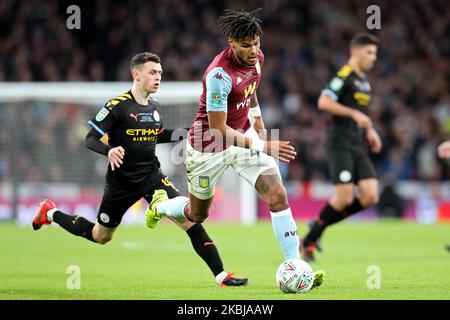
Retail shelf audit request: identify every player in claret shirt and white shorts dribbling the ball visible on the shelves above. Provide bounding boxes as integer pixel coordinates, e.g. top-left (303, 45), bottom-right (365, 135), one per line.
top-left (147, 10), bottom-right (324, 287)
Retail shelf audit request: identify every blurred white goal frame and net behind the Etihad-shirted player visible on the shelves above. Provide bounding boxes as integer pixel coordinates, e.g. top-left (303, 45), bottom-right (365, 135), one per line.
top-left (0, 82), bottom-right (256, 225)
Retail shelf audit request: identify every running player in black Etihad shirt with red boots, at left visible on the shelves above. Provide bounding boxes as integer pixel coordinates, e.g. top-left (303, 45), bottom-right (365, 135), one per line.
top-left (33, 52), bottom-right (247, 286)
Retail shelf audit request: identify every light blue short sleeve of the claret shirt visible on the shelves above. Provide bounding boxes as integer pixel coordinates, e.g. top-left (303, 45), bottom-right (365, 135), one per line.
top-left (206, 68), bottom-right (232, 112)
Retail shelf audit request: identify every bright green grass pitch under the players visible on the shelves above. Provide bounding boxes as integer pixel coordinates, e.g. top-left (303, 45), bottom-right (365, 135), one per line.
top-left (0, 221), bottom-right (450, 300)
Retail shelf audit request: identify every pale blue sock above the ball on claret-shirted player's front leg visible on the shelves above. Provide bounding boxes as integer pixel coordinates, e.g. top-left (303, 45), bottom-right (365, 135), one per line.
top-left (270, 208), bottom-right (300, 260)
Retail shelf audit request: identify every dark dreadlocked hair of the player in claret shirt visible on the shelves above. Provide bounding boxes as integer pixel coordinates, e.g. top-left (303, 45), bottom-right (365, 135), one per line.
top-left (217, 8), bottom-right (263, 41)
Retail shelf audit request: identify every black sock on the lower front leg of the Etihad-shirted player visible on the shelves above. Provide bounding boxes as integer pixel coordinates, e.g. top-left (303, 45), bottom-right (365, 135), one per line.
top-left (186, 223), bottom-right (224, 276)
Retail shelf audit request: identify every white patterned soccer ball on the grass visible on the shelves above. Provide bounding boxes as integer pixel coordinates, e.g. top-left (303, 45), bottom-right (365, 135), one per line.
top-left (275, 259), bottom-right (314, 293)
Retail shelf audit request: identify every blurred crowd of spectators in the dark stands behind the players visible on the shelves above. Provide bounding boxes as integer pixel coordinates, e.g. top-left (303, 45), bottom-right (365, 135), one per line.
top-left (0, 0), bottom-right (450, 181)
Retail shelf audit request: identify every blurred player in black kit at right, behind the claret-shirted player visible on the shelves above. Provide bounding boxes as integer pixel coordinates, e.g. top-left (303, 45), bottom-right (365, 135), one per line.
top-left (300, 33), bottom-right (382, 261)
